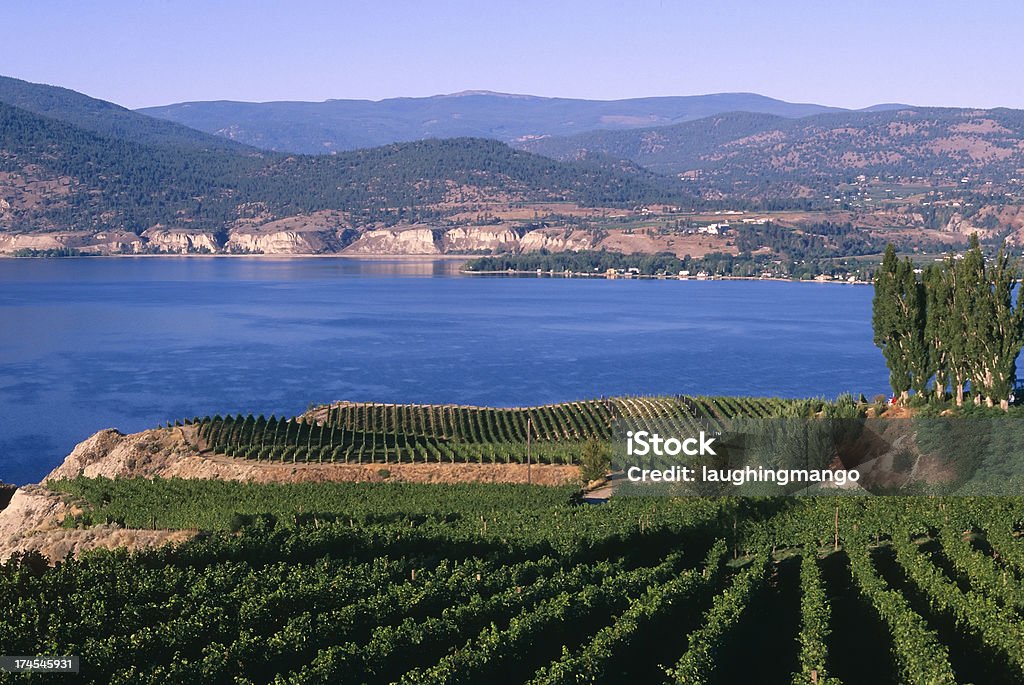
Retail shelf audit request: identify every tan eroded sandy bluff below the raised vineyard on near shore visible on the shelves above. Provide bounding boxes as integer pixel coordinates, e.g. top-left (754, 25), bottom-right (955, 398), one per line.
top-left (0, 426), bottom-right (579, 562)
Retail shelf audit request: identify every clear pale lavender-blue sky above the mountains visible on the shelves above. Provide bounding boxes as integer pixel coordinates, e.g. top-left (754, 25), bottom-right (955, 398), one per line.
top-left (0, 0), bottom-right (1024, 109)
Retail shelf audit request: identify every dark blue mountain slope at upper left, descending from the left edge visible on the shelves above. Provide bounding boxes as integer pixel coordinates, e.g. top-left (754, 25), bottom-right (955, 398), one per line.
top-left (0, 76), bottom-right (245, 151)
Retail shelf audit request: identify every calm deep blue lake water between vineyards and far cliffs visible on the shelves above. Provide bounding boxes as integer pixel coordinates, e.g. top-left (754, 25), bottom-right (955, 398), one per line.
top-left (0, 253), bottom-right (887, 483)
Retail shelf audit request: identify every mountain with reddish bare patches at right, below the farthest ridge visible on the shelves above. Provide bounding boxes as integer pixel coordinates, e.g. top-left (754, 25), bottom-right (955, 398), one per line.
top-left (517, 108), bottom-right (1024, 189)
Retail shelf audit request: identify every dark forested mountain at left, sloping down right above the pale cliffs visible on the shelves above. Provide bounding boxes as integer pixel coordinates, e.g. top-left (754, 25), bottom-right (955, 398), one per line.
top-left (0, 93), bottom-right (692, 233)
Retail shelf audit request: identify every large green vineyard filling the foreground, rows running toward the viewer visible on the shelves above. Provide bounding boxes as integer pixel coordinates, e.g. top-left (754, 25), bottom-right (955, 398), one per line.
top-left (6, 481), bottom-right (1024, 685)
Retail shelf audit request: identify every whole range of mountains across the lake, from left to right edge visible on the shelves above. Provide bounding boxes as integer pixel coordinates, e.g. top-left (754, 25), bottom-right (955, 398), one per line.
top-left (6, 72), bottom-right (1024, 252)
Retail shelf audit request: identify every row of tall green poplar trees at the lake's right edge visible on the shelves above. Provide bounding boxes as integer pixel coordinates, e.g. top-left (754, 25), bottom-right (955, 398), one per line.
top-left (871, 236), bottom-right (1024, 410)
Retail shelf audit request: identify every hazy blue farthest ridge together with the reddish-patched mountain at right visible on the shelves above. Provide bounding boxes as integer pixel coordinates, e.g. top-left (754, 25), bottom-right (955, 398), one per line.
top-left (134, 91), bottom-right (1024, 201)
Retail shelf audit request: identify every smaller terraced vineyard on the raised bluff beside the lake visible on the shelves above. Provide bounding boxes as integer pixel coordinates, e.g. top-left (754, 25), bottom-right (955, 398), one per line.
top-left (186, 396), bottom-right (806, 464)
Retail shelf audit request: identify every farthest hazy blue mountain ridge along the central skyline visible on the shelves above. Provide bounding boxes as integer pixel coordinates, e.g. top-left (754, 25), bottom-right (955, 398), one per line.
top-left (139, 91), bottom-right (840, 154)
